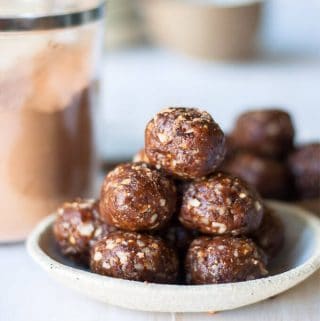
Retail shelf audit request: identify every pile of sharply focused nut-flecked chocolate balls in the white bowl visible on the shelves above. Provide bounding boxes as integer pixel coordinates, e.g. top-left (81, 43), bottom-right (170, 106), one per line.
top-left (53, 108), bottom-right (284, 284)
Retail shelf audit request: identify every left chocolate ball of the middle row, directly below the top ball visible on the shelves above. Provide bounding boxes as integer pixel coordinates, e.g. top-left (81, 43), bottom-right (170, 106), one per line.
top-left (100, 163), bottom-right (177, 231)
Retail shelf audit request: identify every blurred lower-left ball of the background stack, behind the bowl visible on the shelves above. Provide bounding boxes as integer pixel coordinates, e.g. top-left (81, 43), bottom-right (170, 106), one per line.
top-left (222, 152), bottom-right (290, 199)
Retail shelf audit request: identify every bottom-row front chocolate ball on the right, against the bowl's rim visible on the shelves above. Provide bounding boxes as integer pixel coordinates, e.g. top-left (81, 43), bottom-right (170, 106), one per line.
top-left (185, 236), bottom-right (268, 284)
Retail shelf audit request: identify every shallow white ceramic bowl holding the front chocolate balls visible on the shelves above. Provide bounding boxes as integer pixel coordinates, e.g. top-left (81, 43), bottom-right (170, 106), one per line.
top-left (27, 202), bottom-right (320, 312)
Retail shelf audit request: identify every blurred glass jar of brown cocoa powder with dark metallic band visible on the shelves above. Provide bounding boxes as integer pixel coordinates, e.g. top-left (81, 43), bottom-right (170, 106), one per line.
top-left (0, 0), bottom-right (104, 242)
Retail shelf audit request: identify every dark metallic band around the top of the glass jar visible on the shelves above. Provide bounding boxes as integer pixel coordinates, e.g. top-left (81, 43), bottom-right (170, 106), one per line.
top-left (0, 1), bottom-right (105, 33)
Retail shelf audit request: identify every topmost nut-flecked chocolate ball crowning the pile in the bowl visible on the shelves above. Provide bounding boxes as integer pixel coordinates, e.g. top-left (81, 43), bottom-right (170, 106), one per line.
top-left (145, 108), bottom-right (225, 179)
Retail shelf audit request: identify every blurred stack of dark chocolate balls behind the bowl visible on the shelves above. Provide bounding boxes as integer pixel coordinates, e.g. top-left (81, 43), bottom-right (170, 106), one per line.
top-left (222, 109), bottom-right (320, 201)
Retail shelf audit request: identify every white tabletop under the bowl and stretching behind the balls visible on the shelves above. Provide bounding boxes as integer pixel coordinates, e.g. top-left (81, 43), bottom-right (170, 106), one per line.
top-left (0, 49), bottom-right (320, 321)
